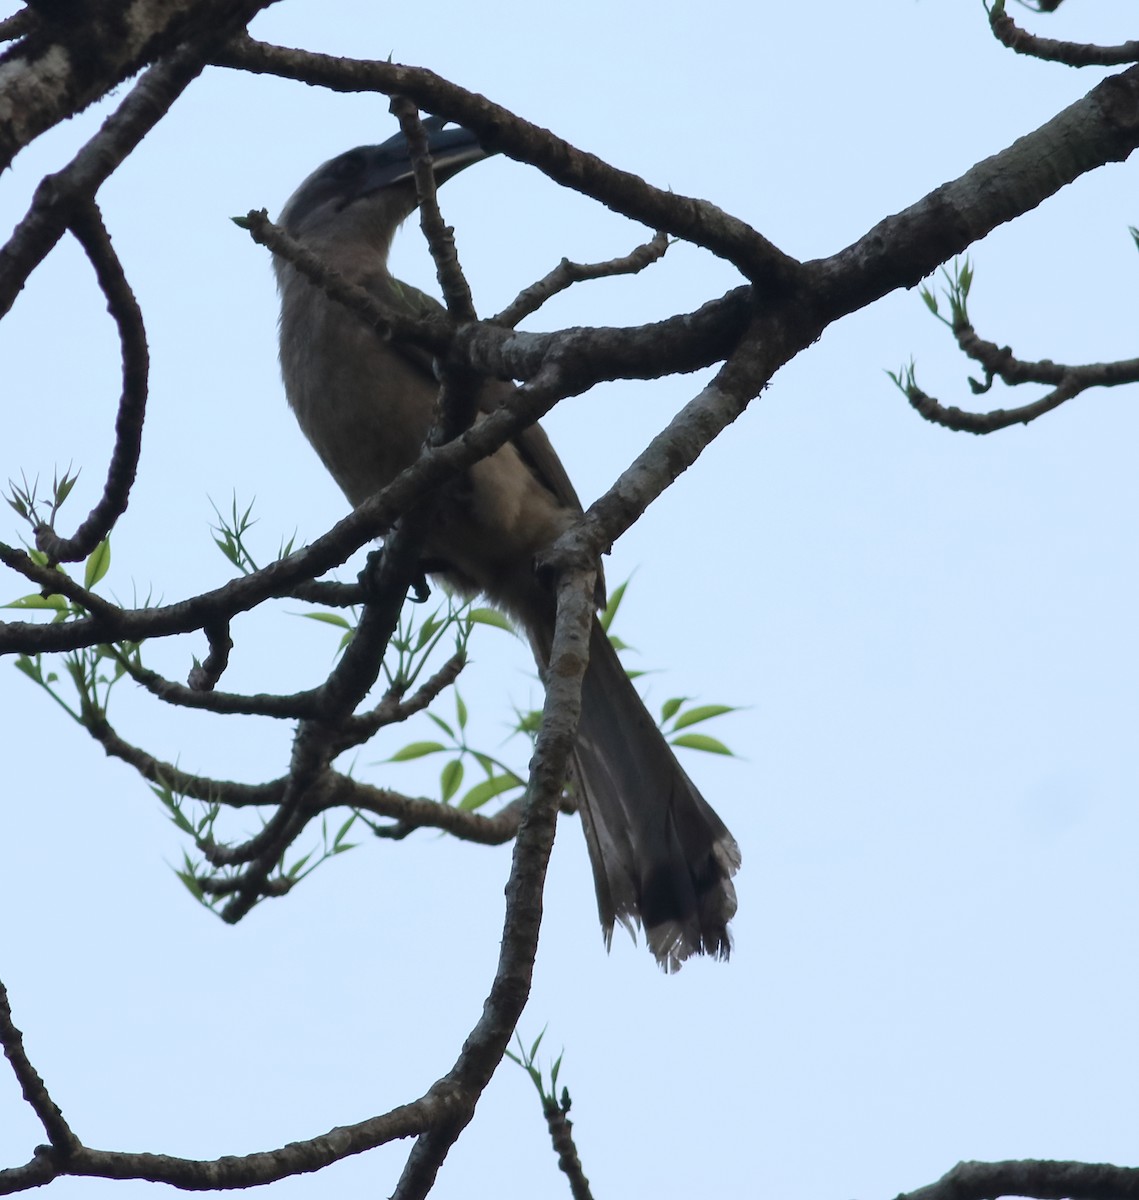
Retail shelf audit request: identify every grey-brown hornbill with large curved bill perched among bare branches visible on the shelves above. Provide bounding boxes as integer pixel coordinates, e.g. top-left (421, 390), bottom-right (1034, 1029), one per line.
top-left (274, 116), bottom-right (741, 972)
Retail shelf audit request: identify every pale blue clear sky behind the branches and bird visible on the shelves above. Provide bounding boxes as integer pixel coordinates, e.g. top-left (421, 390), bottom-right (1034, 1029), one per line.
top-left (0, 0), bottom-right (1139, 1200)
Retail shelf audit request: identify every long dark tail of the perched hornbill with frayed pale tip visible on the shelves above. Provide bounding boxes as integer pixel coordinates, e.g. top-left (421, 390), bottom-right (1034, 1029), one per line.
top-left (574, 618), bottom-right (739, 971)
